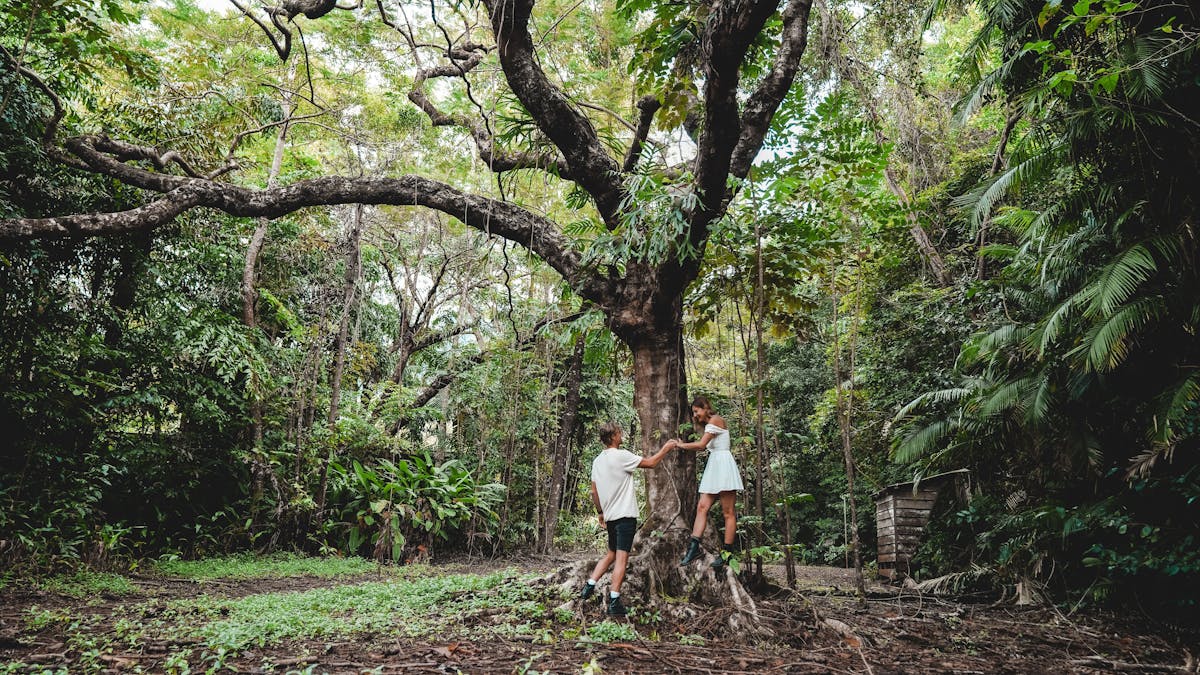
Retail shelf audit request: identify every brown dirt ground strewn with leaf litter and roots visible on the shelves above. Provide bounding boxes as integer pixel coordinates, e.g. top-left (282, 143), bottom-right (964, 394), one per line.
top-left (0, 556), bottom-right (1200, 675)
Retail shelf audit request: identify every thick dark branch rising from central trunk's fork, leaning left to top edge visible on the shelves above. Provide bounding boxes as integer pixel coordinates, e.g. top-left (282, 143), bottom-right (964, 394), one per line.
top-left (485, 0), bottom-right (622, 228)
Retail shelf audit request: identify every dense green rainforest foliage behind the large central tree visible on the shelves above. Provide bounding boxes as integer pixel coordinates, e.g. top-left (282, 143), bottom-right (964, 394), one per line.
top-left (0, 0), bottom-right (1200, 613)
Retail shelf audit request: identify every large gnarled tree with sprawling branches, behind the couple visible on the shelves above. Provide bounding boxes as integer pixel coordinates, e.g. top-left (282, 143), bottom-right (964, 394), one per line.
top-left (0, 0), bottom-right (811, 614)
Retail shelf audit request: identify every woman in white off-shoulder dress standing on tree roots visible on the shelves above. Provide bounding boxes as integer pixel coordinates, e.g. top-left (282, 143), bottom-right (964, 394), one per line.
top-left (676, 396), bottom-right (744, 569)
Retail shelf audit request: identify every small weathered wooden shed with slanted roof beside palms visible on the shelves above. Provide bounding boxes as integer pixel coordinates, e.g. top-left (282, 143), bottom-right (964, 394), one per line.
top-left (875, 468), bottom-right (970, 581)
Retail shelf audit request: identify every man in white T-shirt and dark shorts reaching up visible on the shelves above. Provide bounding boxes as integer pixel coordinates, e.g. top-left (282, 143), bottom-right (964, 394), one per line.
top-left (580, 422), bottom-right (678, 616)
